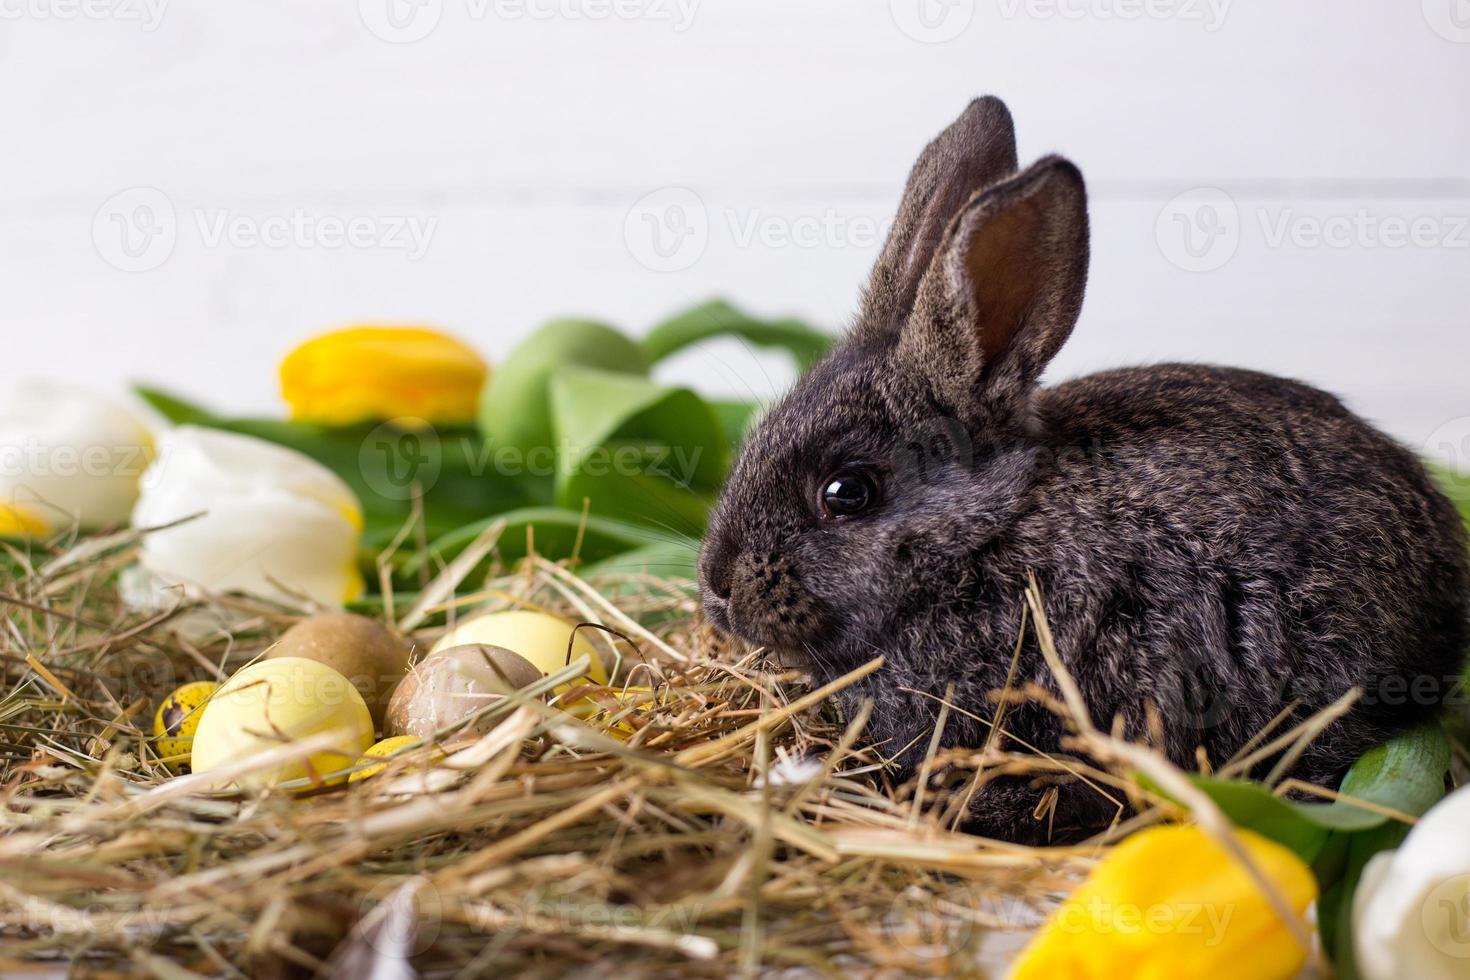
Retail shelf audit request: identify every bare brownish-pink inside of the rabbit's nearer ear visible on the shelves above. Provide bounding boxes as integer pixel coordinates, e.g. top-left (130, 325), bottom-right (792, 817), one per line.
top-left (964, 200), bottom-right (1047, 361)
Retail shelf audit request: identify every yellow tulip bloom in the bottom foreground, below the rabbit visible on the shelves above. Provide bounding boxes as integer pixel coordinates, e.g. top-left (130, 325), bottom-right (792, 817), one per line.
top-left (1010, 826), bottom-right (1317, 980)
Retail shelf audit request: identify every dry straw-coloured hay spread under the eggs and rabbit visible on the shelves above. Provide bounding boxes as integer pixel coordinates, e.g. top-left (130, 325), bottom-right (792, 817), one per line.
top-left (0, 535), bottom-right (1193, 977)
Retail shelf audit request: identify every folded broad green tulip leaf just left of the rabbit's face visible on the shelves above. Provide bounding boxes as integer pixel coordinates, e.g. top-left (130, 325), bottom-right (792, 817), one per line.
top-left (551, 367), bottom-right (729, 536)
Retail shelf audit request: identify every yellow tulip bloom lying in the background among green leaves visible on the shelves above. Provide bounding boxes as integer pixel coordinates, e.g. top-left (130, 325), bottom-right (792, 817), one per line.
top-left (281, 326), bottom-right (488, 425)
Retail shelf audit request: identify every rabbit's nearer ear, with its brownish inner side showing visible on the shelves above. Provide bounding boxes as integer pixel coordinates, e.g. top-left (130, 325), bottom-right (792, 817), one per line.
top-left (900, 157), bottom-right (1088, 416)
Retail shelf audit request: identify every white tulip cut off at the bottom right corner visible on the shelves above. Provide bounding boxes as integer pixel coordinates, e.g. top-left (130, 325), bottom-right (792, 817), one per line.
top-left (1352, 786), bottom-right (1470, 980)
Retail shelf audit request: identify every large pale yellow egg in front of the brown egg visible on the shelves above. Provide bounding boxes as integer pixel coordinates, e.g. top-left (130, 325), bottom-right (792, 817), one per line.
top-left (193, 657), bottom-right (372, 788)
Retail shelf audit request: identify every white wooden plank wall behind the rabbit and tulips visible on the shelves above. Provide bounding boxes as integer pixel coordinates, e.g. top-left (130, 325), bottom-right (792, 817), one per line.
top-left (0, 0), bottom-right (1470, 464)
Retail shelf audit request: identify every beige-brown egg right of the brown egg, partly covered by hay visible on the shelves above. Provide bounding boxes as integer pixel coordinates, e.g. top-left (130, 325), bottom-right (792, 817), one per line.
top-left (384, 644), bottom-right (542, 739)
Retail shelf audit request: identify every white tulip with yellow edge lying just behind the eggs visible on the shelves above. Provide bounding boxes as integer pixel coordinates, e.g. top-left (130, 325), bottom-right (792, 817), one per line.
top-left (132, 426), bottom-right (363, 607)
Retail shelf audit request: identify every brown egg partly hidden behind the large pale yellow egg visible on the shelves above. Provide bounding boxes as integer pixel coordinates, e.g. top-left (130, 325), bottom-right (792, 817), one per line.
top-left (266, 613), bottom-right (409, 724)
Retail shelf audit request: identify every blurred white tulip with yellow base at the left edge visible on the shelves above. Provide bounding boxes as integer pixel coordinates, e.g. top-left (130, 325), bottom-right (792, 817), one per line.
top-left (0, 381), bottom-right (153, 533)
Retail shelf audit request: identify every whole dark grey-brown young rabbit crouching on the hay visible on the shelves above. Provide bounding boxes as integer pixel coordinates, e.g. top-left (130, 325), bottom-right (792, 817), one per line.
top-left (700, 98), bottom-right (1470, 840)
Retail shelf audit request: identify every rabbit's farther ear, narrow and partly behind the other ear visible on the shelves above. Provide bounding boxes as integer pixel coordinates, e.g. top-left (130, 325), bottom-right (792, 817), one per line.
top-left (858, 96), bottom-right (1016, 332)
